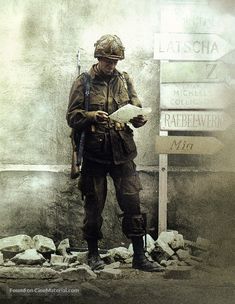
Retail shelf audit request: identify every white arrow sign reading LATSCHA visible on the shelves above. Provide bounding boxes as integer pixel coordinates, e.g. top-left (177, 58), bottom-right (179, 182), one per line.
top-left (154, 33), bottom-right (232, 61)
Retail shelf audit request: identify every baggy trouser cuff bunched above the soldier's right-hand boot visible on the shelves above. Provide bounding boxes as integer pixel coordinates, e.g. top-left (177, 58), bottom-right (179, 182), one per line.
top-left (122, 214), bottom-right (146, 238)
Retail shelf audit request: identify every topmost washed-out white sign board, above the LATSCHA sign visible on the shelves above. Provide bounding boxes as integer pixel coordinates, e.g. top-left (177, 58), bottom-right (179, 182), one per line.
top-left (161, 1), bottom-right (219, 33)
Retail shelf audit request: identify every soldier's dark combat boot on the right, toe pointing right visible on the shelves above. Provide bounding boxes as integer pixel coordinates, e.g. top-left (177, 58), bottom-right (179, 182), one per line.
top-left (132, 236), bottom-right (165, 272)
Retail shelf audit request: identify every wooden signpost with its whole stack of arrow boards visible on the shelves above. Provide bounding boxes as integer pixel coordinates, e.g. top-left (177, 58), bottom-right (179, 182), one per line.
top-left (154, 0), bottom-right (233, 234)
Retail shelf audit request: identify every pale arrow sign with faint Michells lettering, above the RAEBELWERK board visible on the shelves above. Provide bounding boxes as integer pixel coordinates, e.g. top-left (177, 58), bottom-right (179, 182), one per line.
top-left (160, 83), bottom-right (233, 109)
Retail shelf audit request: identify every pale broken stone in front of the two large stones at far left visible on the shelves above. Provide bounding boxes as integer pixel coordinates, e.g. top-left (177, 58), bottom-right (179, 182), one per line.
top-left (11, 249), bottom-right (45, 265)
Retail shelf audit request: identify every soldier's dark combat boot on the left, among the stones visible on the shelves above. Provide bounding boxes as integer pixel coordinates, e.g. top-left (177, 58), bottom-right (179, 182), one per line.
top-left (87, 239), bottom-right (105, 270)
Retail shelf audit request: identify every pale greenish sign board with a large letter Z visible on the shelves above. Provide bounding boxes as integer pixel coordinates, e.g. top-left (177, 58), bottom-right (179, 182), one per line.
top-left (161, 61), bottom-right (229, 83)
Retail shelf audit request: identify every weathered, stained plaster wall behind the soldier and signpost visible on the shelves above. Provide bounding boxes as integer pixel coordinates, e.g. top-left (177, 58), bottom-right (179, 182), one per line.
top-left (0, 0), bottom-right (235, 258)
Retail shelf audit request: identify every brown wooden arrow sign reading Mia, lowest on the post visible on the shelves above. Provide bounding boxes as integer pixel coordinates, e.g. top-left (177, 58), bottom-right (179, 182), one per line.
top-left (155, 136), bottom-right (223, 155)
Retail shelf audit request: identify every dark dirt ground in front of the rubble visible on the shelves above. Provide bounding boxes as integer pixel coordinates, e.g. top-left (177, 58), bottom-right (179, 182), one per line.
top-left (0, 266), bottom-right (235, 304)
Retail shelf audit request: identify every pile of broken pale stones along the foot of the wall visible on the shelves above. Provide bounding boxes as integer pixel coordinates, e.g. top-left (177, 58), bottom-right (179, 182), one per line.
top-left (0, 231), bottom-right (211, 282)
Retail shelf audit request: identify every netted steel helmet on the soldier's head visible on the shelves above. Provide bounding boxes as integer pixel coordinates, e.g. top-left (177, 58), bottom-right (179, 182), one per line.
top-left (94, 35), bottom-right (125, 60)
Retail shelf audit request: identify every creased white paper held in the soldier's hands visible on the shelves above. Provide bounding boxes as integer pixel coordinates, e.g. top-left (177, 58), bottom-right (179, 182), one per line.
top-left (109, 104), bottom-right (152, 123)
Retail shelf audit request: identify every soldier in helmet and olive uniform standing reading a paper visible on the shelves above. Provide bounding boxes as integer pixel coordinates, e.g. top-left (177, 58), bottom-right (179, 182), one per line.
top-left (67, 35), bottom-right (163, 272)
